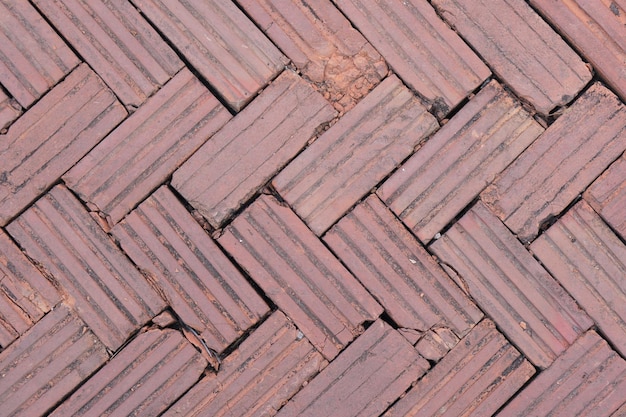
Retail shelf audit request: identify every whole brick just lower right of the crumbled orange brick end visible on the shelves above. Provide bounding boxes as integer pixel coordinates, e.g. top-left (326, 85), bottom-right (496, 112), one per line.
top-left (272, 76), bottom-right (437, 235)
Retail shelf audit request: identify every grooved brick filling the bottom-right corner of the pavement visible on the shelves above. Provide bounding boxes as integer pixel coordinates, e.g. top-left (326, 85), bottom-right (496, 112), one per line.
top-left (498, 331), bottom-right (626, 417)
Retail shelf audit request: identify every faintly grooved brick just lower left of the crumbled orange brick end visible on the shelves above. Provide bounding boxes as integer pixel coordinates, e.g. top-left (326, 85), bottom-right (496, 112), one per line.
top-left (172, 71), bottom-right (335, 227)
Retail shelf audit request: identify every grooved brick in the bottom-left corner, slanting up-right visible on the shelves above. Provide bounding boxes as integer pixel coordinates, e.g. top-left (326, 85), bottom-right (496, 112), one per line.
top-left (0, 304), bottom-right (108, 417)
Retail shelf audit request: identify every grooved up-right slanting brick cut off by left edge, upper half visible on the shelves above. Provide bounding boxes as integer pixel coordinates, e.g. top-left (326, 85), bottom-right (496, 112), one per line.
top-left (0, 65), bottom-right (126, 226)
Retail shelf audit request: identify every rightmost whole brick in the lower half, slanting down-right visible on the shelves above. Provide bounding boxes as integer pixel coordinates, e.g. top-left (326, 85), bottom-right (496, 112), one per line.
top-left (431, 202), bottom-right (593, 368)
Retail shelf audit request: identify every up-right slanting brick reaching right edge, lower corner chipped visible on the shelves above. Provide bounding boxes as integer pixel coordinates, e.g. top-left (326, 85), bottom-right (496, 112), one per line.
top-left (481, 84), bottom-right (626, 242)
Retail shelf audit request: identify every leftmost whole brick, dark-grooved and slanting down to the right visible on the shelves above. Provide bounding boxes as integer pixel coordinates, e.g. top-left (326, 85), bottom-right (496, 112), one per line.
top-left (7, 185), bottom-right (165, 350)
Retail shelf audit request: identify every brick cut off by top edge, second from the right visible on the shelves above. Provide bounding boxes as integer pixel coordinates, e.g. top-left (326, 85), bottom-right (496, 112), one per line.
top-left (433, 0), bottom-right (591, 114)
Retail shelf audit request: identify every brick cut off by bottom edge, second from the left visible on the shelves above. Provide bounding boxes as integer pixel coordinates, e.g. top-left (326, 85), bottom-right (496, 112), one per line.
top-left (50, 329), bottom-right (207, 416)
